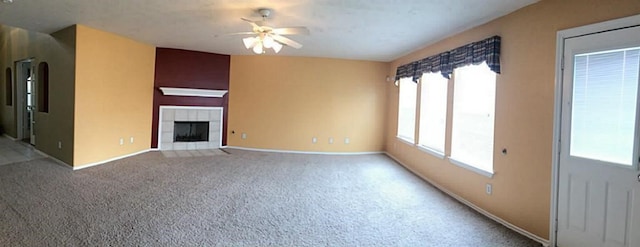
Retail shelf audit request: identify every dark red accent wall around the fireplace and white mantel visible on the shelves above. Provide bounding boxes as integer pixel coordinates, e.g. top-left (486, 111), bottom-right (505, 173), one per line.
top-left (151, 48), bottom-right (231, 148)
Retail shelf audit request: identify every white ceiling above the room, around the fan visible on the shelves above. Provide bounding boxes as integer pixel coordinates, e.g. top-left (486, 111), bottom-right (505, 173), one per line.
top-left (0, 0), bottom-right (538, 61)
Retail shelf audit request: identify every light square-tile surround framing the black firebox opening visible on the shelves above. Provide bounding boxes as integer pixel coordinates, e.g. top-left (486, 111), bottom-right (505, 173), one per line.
top-left (158, 106), bottom-right (223, 150)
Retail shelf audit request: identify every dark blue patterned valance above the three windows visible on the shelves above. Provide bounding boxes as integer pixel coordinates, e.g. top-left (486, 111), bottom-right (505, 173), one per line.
top-left (396, 36), bottom-right (500, 82)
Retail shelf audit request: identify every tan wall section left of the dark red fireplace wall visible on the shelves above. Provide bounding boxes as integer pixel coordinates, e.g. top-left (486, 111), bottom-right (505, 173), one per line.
top-left (73, 25), bottom-right (155, 167)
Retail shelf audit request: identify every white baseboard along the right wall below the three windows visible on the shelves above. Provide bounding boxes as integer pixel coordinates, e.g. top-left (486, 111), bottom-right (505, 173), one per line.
top-left (385, 153), bottom-right (549, 247)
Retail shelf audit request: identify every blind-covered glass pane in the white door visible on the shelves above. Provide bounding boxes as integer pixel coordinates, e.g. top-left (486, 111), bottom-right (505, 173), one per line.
top-left (570, 48), bottom-right (640, 165)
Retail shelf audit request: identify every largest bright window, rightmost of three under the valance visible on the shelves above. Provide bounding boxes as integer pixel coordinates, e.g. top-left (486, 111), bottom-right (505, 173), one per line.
top-left (451, 63), bottom-right (496, 175)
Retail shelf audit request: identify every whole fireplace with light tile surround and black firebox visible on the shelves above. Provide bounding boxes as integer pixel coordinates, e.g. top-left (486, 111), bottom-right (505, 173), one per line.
top-left (158, 106), bottom-right (222, 150)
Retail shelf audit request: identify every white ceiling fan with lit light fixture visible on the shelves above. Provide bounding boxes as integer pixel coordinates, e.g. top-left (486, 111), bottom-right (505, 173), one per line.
top-left (232, 8), bottom-right (310, 54)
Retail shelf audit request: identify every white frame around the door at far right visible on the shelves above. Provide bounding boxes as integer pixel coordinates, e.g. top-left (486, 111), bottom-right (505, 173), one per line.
top-left (549, 15), bottom-right (640, 246)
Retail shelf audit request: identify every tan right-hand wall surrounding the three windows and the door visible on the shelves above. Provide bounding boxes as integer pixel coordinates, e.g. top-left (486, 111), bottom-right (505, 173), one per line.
top-left (386, 0), bottom-right (640, 238)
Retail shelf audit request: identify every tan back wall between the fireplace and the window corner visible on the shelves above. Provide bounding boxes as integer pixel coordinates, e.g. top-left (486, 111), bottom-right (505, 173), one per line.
top-left (228, 56), bottom-right (389, 152)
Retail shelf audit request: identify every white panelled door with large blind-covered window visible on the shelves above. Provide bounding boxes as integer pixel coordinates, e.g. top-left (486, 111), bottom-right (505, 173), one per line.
top-left (557, 26), bottom-right (640, 247)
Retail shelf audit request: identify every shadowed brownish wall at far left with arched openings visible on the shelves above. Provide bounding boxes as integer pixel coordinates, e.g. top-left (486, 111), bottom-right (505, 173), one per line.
top-left (0, 25), bottom-right (75, 163)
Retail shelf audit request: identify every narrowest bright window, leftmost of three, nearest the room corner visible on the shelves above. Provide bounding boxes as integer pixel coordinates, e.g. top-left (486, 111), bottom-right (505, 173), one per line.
top-left (398, 78), bottom-right (418, 142)
